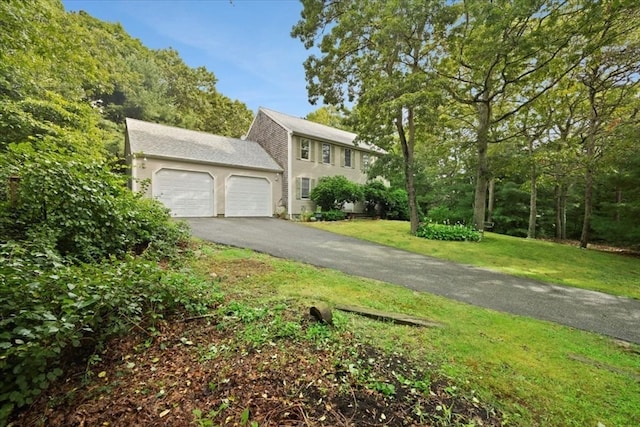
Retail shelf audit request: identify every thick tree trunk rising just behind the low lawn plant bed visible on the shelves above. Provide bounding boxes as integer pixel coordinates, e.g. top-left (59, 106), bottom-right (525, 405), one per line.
top-left (473, 101), bottom-right (491, 231)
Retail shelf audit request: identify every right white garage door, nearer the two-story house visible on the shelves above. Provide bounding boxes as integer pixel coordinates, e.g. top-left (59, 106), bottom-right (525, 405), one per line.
top-left (224, 175), bottom-right (272, 216)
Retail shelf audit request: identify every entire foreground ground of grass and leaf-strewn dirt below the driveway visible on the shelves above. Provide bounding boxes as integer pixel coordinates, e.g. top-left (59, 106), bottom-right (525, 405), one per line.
top-left (10, 244), bottom-right (640, 426)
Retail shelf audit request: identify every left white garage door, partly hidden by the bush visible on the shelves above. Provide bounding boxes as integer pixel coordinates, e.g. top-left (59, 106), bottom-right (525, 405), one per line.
top-left (152, 169), bottom-right (213, 217)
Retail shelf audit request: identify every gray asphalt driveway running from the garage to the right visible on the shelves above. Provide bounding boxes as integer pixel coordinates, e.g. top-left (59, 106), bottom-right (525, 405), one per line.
top-left (187, 218), bottom-right (640, 344)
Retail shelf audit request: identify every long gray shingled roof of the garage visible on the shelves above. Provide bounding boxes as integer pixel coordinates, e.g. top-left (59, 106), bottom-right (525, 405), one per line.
top-left (126, 118), bottom-right (282, 171)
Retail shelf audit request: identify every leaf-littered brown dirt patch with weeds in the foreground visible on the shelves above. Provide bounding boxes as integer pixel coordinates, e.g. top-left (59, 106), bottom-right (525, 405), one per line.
top-left (13, 306), bottom-right (500, 426)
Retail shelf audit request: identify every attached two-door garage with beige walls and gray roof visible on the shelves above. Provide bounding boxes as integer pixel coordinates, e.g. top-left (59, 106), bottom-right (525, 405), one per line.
top-left (125, 119), bottom-right (283, 217)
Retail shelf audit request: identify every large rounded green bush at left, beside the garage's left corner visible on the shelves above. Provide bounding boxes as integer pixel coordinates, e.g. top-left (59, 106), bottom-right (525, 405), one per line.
top-left (0, 147), bottom-right (186, 262)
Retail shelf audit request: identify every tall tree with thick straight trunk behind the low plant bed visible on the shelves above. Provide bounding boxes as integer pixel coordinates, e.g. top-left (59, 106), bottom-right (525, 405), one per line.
top-left (437, 0), bottom-right (604, 229)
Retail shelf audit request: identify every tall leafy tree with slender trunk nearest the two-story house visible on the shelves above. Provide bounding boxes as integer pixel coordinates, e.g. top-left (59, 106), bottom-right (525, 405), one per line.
top-left (292, 0), bottom-right (446, 233)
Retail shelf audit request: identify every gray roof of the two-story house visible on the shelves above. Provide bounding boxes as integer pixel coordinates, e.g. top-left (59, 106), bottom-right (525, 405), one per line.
top-left (260, 107), bottom-right (381, 152)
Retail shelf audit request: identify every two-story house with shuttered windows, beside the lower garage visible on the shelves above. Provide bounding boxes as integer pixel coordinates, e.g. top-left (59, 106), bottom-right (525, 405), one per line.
top-left (246, 107), bottom-right (380, 218)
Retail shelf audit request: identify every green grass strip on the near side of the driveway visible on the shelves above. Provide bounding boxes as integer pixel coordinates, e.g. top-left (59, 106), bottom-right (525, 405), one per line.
top-left (190, 246), bottom-right (640, 426)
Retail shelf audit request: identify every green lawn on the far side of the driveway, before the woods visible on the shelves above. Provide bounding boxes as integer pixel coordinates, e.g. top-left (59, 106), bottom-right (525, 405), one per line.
top-left (305, 220), bottom-right (640, 299)
